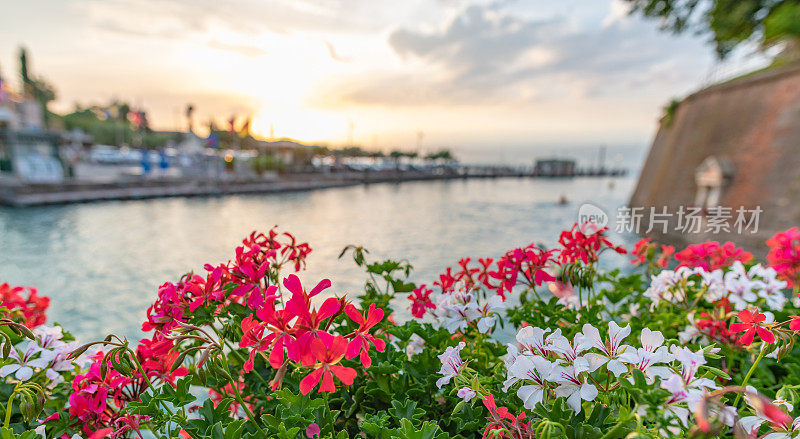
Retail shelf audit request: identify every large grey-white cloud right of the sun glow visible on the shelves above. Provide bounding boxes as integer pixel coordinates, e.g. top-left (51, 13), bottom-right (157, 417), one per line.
top-left (316, 3), bottom-right (707, 105)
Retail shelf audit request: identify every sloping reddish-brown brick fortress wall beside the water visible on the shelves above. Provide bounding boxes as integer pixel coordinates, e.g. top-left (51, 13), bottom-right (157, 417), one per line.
top-left (630, 65), bottom-right (800, 254)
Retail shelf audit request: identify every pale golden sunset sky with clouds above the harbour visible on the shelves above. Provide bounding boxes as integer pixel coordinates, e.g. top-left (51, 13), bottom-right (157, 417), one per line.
top-left (0, 0), bottom-right (764, 148)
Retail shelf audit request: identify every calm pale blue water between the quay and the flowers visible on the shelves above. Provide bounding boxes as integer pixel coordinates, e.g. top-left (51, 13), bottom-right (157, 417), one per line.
top-left (0, 177), bottom-right (635, 341)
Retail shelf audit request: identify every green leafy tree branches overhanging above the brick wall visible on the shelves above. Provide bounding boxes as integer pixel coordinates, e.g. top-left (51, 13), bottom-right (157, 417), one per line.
top-left (625, 0), bottom-right (800, 58)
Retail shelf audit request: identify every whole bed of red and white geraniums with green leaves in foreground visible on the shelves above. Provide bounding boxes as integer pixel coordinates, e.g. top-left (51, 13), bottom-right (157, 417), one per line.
top-left (7, 224), bottom-right (800, 439)
